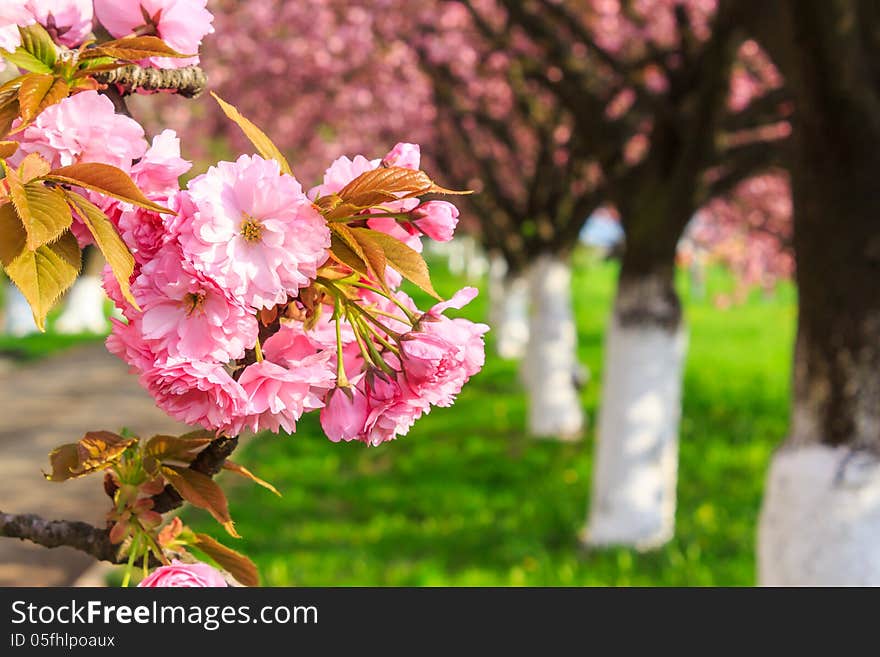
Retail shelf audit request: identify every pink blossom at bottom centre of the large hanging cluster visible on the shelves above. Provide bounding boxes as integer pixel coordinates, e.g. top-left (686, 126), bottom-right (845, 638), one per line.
top-left (230, 352), bottom-right (336, 434)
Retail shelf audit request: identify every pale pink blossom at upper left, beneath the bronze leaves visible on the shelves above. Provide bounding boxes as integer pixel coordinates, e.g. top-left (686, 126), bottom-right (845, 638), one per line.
top-left (16, 91), bottom-right (147, 171)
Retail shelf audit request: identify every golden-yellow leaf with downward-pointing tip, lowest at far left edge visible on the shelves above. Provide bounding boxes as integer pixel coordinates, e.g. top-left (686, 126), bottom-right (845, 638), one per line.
top-left (0, 211), bottom-right (81, 331)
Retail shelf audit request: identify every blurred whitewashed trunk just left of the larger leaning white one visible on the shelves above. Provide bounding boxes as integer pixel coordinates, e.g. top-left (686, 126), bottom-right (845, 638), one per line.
top-left (524, 255), bottom-right (584, 440)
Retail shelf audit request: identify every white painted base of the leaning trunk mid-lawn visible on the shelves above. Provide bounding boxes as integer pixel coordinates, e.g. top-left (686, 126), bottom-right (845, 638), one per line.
top-left (584, 317), bottom-right (687, 549)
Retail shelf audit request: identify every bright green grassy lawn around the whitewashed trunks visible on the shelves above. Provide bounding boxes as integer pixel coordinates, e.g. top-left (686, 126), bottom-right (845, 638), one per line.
top-left (185, 254), bottom-right (795, 586)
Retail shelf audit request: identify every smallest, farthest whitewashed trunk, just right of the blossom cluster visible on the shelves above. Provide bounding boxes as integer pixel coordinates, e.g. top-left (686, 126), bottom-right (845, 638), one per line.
top-left (489, 254), bottom-right (529, 360)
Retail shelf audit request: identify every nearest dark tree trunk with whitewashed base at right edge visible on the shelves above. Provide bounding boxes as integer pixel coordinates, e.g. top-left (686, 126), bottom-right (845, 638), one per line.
top-left (758, 0), bottom-right (880, 586)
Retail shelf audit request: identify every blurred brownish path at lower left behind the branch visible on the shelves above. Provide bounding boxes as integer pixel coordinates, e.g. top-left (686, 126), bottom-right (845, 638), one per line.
top-left (0, 343), bottom-right (185, 586)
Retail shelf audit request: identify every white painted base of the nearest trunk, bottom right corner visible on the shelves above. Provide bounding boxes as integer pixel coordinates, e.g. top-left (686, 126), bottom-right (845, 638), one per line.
top-left (758, 445), bottom-right (880, 586)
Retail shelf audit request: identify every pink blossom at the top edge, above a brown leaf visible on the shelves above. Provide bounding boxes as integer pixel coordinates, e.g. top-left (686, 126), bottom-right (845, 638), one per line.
top-left (95, 0), bottom-right (214, 68)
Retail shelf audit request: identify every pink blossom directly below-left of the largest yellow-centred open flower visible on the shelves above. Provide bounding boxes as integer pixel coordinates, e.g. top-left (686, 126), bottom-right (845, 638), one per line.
top-left (132, 246), bottom-right (257, 363)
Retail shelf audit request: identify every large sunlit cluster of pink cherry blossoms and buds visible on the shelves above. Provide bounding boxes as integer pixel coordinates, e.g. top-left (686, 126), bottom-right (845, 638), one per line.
top-left (105, 140), bottom-right (488, 445)
